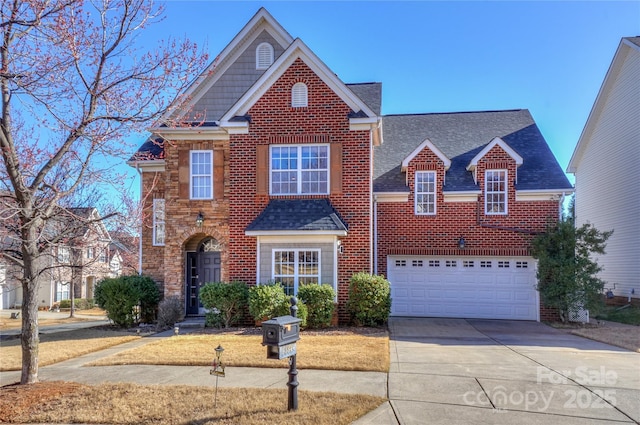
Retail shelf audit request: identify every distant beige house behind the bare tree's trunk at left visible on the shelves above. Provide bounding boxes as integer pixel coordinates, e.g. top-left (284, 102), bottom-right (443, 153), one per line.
top-left (0, 208), bottom-right (113, 309)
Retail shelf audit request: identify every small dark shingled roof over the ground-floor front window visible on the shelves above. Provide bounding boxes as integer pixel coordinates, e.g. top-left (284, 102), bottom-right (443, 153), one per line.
top-left (245, 199), bottom-right (347, 236)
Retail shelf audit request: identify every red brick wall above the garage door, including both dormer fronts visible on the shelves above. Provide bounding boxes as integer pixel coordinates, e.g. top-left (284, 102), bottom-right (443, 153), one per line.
top-left (377, 142), bottom-right (559, 319)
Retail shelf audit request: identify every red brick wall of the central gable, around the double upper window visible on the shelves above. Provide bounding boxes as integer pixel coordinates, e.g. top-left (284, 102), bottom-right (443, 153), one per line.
top-left (229, 59), bottom-right (371, 318)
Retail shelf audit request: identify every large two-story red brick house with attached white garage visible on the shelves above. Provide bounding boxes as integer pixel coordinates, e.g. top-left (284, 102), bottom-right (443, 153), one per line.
top-left (129, 9), bottom-right (573, 320)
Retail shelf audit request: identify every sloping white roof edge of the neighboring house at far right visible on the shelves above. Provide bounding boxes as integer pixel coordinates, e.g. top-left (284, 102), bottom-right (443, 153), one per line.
top-left (567, 37), bottom-right (640, 173)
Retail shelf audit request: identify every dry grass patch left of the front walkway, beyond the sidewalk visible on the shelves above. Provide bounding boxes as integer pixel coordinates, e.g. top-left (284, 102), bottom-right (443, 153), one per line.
top-left (0, 329), bottom-right (140, 371)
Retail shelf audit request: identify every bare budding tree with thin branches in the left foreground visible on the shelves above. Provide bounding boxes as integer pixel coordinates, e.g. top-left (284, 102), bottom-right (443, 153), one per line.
top-left (0, 0), bottom-right (207, 384)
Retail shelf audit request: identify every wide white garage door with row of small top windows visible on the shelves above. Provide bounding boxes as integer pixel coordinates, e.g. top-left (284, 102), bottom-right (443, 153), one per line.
top-left (387, 256), bottom-right (539, 320)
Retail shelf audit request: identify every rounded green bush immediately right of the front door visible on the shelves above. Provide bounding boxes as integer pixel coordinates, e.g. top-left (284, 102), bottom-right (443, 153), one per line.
top-left (199, 282), bottom-right (249, 328)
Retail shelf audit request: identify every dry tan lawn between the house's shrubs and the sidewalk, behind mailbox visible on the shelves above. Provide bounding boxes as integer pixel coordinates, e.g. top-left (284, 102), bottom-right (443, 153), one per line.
top-left (90, 332), bottom-right (389, 372)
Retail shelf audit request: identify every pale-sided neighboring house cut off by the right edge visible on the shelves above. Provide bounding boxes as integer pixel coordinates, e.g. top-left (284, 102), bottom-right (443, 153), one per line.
top-left (567, 37), bottom-right (640, 301)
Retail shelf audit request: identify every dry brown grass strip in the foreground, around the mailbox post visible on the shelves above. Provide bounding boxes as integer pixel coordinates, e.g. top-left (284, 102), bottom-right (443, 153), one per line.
top-left (0, 382), bottom-right (386, 425)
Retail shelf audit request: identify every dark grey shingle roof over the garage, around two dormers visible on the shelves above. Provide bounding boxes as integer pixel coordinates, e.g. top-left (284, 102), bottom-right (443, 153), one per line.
top-left (373, 109), bottom-right (573, 192)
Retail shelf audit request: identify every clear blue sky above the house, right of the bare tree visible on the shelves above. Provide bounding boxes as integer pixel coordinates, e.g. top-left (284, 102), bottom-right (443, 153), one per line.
top-left (124, 0), bottom-right (640, 192)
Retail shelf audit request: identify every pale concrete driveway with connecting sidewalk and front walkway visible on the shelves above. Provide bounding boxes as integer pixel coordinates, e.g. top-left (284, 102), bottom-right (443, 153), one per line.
top-left (0, 318), bottom-right (640, 425)
